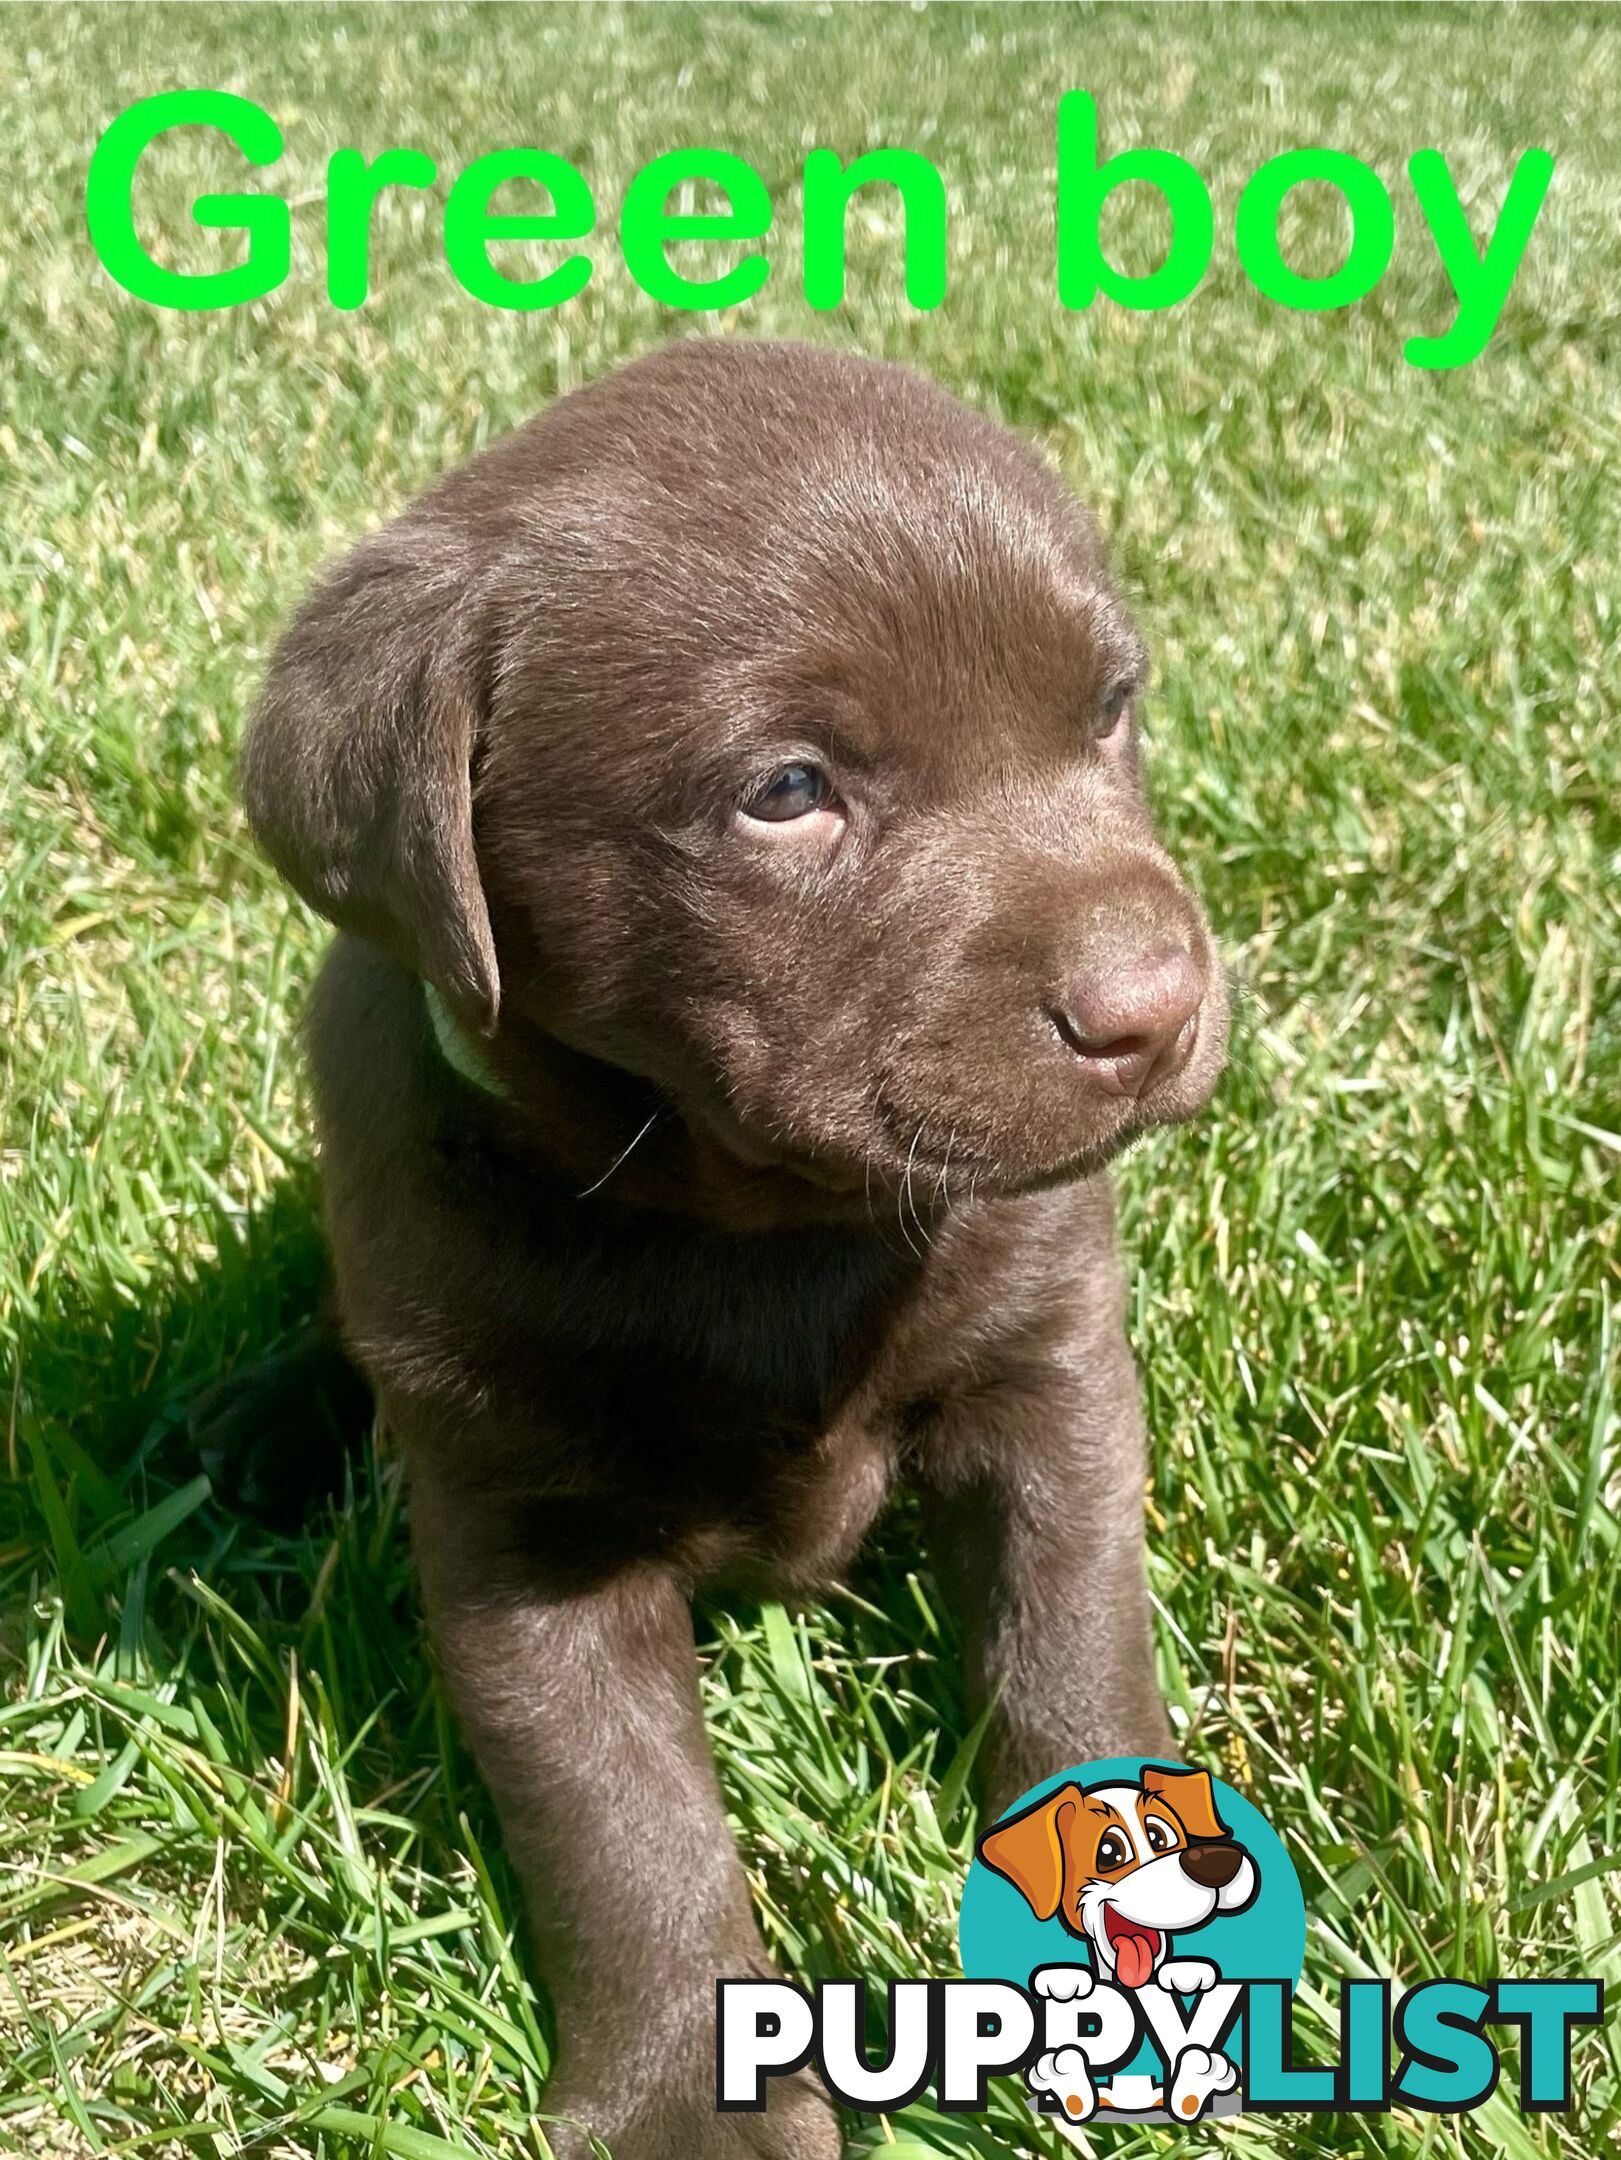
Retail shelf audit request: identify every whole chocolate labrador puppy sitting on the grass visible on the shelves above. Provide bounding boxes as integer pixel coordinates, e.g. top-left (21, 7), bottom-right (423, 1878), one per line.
top-left (234, 339), bottom-right (1225, 2160)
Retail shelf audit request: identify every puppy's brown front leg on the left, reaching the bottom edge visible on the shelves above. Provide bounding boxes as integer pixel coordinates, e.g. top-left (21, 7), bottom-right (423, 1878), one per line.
top-left (413, 1464), bottom-right (839, 2160)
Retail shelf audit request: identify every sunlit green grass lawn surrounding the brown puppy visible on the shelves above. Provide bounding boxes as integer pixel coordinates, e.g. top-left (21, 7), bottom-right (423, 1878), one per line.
top-left (0, 6), bottom-right (1621, 2160)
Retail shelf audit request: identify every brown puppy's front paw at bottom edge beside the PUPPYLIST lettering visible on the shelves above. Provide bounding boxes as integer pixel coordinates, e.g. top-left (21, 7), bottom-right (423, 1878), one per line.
top-left (542, 2071), bottom-right (843, 2160)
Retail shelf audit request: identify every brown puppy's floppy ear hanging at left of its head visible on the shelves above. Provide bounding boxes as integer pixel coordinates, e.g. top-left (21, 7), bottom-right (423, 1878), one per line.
top-left (242, 514), bottom-right (499, 1028)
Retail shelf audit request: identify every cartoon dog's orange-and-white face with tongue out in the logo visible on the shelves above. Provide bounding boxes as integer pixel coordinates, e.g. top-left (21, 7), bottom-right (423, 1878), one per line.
top-left (979, 1763), bottom-right (1260, 1987)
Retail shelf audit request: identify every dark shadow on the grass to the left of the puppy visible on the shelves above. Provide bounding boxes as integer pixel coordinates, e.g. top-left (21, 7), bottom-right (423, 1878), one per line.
top-left (0, 1166), bottom-right (493, 1874)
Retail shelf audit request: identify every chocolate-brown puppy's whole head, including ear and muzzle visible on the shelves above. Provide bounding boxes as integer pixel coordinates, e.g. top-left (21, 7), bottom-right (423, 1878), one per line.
top-left (244, 341), bottom-right (1225, 1192)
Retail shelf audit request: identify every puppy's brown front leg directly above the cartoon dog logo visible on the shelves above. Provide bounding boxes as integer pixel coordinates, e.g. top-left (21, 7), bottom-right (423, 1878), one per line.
top-left (919, 1298), bottom-right (1171, 1814)
